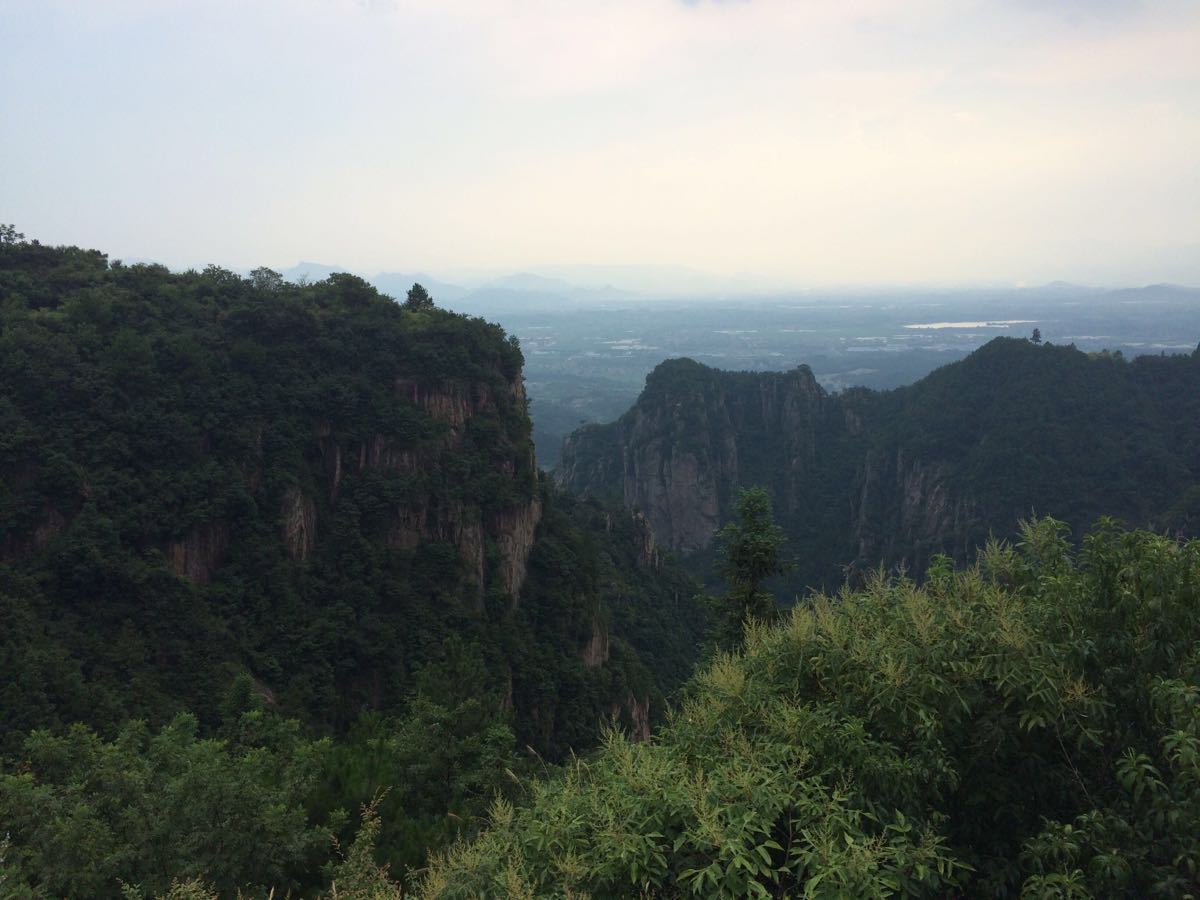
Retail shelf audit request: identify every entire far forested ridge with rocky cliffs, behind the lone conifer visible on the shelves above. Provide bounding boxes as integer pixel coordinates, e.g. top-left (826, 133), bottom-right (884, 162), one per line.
top-left (558, 338), bottom-right (1200, 589)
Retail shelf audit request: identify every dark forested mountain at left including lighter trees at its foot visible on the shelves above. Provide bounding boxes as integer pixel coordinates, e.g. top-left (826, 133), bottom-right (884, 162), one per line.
top-left (0, 234), bottom-right (703, 895)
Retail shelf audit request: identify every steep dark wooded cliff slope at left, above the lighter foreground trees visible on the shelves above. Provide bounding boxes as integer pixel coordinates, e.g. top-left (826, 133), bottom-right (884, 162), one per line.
top-left (0, 242), bottom-right (691, 755)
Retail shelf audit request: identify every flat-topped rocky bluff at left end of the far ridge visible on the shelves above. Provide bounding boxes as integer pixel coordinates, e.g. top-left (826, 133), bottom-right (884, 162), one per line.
top-left (558, 360), bottom-right (874, 588)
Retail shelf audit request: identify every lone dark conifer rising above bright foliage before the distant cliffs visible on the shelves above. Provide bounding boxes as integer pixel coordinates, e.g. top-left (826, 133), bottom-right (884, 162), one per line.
top-left (716, 487), bottom-right (791, 647)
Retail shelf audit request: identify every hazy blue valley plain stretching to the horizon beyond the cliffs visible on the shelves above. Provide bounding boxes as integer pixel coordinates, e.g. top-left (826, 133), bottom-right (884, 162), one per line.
top-left (270, 264), bottom-right (1200, 469)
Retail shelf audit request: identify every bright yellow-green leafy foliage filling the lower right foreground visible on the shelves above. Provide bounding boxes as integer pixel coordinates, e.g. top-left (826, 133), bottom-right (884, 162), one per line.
top-left (422, 520), bottom-right (1200, 898)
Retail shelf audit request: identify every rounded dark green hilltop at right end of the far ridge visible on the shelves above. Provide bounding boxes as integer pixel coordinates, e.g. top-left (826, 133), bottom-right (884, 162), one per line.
top-left (869, 338), bottom-right (1200, 564)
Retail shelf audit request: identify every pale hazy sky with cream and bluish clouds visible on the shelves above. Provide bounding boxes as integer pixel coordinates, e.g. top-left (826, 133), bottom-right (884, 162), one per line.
top-left (0, 0), bottom-right (1200, 286)
